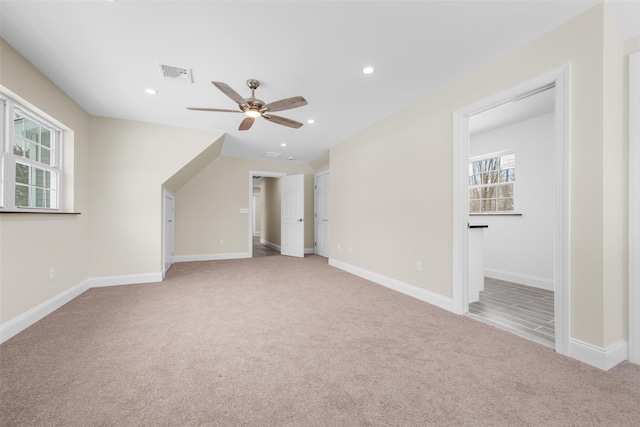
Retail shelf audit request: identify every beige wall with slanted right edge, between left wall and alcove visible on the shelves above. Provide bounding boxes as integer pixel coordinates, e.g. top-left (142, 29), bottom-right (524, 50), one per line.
top-left (90, 117), bottom-right (221, 277)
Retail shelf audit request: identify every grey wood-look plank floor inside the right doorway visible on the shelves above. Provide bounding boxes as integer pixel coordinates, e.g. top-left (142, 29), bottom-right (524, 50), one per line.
top-left (469, 277), bottom-right (555, 348)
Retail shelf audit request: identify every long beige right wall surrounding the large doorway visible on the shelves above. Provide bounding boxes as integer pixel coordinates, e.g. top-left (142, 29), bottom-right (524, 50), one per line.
top-left (330, 5), bottom-right (626, 347)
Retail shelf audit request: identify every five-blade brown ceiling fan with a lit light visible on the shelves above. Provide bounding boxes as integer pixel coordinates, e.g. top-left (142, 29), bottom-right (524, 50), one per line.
top-left (187, 79), bottom-right (307, 130)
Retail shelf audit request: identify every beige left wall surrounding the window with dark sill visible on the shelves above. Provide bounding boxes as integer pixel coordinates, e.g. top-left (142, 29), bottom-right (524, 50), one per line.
top-left (0, 39), bottom-right (92, 324)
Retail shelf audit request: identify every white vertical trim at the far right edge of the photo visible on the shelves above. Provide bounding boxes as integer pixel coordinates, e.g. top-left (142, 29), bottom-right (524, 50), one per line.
top-left (629, 52), bottom-right (640, 363)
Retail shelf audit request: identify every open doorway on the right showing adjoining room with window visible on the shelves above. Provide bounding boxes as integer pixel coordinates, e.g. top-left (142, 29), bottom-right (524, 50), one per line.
top-left (468, 85), bottom-right (555, 348)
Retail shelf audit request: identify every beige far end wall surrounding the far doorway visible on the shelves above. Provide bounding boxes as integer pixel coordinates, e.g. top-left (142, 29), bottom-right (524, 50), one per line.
top-left (175, 157), bottom-right (313, 256)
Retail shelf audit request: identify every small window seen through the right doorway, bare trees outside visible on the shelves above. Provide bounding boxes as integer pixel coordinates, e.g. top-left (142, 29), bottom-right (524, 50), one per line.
top-left (469, 153), bottom-right (516, 213)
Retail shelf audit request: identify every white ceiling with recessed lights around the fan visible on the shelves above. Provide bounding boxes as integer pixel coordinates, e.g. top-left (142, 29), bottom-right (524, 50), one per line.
top-left (0, 0), bottom-right (640, 162)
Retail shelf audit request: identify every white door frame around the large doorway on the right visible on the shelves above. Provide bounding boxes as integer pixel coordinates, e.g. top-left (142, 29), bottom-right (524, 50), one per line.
top-left (452, 64), bottom-right (571, 355)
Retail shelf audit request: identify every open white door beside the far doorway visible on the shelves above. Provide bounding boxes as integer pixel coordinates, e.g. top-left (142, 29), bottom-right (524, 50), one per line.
top-left (280, 175), bottom-right (304, 258)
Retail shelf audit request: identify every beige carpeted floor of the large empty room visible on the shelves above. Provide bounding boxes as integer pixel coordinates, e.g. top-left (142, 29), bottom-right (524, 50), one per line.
top-left (0, 256), bottom-right (640, 426)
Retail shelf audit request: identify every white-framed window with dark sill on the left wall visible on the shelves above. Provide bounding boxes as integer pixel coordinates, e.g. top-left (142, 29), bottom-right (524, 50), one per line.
top-left (0, 97), bottom-right (62, 210)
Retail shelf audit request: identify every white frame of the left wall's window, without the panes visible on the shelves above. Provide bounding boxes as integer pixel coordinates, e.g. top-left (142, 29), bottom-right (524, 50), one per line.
top-left (0, 94), bottom-right (64, 212)
